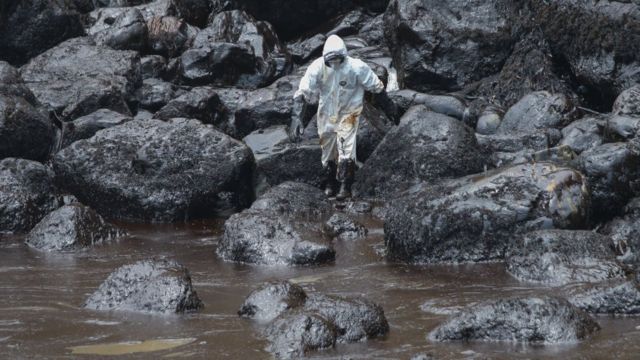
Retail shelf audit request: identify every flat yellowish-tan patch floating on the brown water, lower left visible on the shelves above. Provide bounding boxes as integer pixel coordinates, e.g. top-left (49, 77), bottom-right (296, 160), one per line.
top-left (68, 338), bottom-right (196, 356)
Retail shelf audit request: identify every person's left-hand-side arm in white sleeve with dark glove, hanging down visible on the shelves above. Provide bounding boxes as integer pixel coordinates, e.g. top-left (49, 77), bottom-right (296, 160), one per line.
top-left (289, 61), bottom-right (321, 141)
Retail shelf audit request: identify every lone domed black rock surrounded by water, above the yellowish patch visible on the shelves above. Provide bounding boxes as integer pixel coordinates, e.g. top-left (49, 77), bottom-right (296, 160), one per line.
top-left (84, 260), bottom-right (202, 314)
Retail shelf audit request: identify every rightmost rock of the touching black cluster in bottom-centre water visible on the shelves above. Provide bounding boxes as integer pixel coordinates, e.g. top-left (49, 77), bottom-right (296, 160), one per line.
top-left (304, 293), bottom-right (389, 343)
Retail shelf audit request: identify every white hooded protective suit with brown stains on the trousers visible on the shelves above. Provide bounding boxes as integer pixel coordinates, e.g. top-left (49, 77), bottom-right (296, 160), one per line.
top-left (294, 35), bottom-right (384, 166)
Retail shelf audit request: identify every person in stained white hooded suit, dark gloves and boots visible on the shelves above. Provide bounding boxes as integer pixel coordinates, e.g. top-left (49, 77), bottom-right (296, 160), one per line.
top-left (290, 35), bottom-right (393, 200)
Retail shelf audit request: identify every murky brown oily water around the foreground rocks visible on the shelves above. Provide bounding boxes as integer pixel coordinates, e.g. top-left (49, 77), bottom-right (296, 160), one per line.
top-left (0, 214), bottom-right (640, 360)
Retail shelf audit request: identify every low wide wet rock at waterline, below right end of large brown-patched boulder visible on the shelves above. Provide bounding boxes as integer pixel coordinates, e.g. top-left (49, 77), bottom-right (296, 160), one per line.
top-left (506, 230), bottom-right (625, 285)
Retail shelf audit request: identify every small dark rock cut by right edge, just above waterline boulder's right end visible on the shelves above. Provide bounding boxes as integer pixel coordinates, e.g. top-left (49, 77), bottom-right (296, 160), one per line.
top-left (599, 198), bottom-right (640, 268)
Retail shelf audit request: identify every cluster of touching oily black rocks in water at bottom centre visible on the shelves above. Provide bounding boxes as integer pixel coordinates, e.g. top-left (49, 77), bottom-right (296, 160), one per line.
top-left (238, 282), bottom-right (389, 359)
